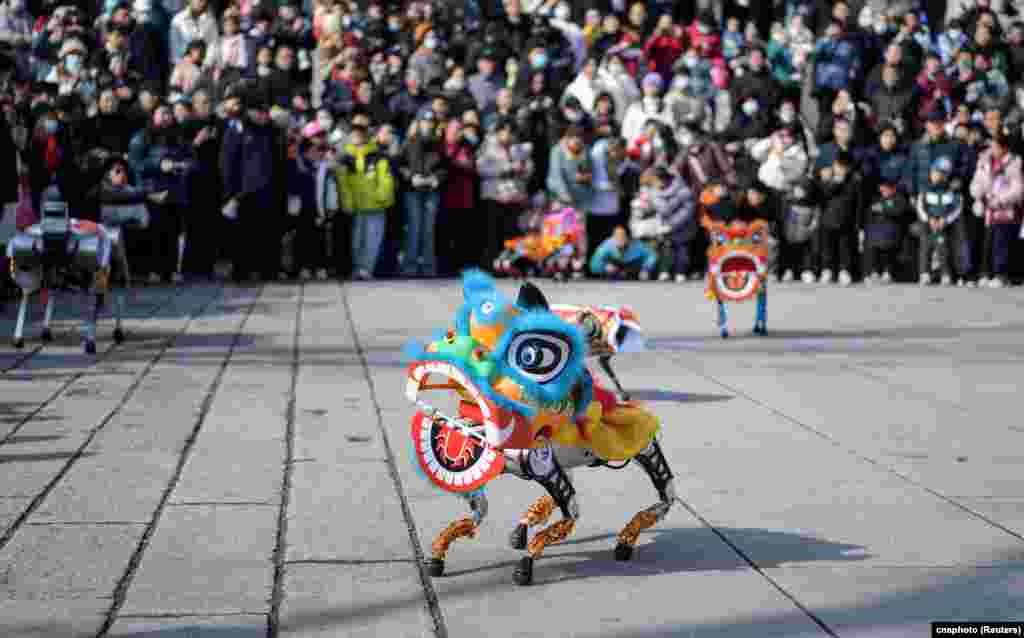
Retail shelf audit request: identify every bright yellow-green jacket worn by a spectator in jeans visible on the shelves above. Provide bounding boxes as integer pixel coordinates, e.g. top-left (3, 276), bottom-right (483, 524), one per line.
top-left (335, 142), bottom-right (395, 215)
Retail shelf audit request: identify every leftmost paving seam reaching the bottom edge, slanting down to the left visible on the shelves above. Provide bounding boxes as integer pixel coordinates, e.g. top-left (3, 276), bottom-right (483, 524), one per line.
top-left (96, 285), bottom-right (266, 638)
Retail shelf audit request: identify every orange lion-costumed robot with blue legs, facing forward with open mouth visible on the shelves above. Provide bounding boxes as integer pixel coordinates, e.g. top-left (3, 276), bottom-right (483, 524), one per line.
top-left (700, 185), bottom-right (769, 339)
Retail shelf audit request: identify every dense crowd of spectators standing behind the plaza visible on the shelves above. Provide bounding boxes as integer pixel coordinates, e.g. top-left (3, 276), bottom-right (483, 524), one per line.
top-left (0, 0), bottom-right (1024, 287)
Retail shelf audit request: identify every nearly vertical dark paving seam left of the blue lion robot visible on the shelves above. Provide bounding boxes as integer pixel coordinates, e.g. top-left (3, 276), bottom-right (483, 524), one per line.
top-left (266, 284), bottom-right (306, 638)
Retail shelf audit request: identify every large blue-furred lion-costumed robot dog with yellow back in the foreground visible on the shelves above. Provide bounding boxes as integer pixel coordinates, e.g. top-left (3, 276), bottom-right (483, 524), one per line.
top-left (406, 271), bottom-right (676, 585)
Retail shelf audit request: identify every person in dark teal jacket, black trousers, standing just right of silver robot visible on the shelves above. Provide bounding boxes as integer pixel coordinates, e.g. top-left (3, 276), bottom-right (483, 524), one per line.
top-left (128, 103), bottom-right (199, 284)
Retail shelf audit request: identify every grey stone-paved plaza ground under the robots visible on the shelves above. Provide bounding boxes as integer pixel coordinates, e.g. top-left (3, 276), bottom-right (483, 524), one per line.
top-left (0, 281), bottom-right (1024, 638)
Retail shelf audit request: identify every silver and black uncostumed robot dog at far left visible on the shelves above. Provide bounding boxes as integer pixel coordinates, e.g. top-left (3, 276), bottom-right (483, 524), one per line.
top-left (7, 186), bottom-right (128, 354)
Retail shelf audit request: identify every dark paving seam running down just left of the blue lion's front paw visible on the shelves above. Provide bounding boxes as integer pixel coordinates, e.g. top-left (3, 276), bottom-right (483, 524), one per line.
top-left (338, 283), bottom-right (449, 638)
